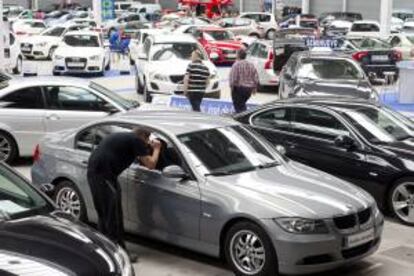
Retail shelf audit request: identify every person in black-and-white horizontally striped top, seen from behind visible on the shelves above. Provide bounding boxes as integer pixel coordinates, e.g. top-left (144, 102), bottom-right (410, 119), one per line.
top-left (184, 50), bottom-right (210, 112)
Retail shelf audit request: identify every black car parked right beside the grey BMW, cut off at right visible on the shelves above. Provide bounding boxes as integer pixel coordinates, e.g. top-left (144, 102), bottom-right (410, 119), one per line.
top-left (235, 98), bottom-right (414, 226)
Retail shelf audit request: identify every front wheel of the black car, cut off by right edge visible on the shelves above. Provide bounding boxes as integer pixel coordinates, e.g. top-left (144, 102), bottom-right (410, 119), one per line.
top-left (388, 178), bottom-right (414, 226)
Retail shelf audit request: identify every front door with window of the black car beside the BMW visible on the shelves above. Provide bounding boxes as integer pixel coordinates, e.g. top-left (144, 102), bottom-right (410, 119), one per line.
top-left (286, 107), bottom-right (368, 183)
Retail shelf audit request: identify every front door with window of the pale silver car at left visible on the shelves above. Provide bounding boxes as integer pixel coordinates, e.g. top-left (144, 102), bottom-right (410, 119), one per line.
top-left (43, 85), bottom-right (117, 132)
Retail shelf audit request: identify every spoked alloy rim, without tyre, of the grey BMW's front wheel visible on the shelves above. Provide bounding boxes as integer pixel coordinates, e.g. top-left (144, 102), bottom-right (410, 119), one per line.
top-left (230, 230), bottom-right (266, 275)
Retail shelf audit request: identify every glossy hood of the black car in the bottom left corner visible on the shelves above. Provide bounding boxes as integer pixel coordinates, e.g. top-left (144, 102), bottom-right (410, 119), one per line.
top-left (0, 212), bottom-right (120, 275)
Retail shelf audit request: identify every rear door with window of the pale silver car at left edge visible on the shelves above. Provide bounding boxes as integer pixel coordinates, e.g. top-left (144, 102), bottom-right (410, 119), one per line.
top-left (0, 86), bottom-right (46, 156)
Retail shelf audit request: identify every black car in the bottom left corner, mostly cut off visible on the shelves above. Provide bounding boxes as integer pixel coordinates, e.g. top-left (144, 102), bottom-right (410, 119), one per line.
top-left (0, 164), bottom-right (134, 276)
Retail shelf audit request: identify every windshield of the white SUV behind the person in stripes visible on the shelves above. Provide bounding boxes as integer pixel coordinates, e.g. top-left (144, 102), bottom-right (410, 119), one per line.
top-left (152, 43), bottom-right (207, 61)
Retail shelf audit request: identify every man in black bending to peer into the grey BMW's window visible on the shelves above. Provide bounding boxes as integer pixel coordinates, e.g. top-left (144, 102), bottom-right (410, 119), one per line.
top-left (88, 129), bottom-right (161, 256)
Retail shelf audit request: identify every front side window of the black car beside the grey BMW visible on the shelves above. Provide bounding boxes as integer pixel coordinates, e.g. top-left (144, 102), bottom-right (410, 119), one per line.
top-left (292, 108), bottom-right (349, 142)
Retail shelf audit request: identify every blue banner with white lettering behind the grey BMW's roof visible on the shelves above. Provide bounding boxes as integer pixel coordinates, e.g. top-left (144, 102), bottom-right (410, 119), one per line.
top-left (169, 96), bottom-right (257, 115)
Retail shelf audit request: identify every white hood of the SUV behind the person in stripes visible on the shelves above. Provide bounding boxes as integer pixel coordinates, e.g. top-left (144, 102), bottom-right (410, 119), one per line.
top-left (148, 58), bottom-right (217, 76)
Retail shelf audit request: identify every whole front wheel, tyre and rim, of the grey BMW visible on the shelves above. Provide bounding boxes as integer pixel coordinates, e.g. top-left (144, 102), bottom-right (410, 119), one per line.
top-left (224, 221), bottom-right (278, 276)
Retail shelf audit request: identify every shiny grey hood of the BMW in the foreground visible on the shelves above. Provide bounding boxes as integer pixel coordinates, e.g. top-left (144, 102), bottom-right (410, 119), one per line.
top-left (209, 161), bottom-right (374, 219)
